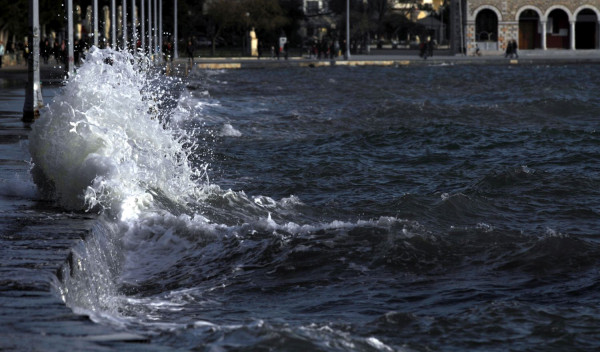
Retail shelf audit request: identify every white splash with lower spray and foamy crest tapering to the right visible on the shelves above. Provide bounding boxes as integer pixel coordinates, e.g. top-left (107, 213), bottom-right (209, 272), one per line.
top-left (29, 48), bottom-right (420, 336)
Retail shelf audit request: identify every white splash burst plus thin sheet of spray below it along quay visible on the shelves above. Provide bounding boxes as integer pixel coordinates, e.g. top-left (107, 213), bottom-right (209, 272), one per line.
top-left (29, 47), bottom-right (211, 320)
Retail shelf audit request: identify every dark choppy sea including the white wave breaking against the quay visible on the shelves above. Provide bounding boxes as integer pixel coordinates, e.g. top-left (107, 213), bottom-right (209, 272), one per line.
top-left (0, 53), bottom-right (600, 351)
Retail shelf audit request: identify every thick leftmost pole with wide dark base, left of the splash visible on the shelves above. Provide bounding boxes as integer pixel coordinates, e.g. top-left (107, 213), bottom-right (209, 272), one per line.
top-left (23, 0), bottom-right (44, 122)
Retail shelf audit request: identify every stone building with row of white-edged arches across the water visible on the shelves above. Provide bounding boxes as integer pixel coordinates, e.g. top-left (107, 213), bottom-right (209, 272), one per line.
top-left (453, 0), bottom-right (600, 52)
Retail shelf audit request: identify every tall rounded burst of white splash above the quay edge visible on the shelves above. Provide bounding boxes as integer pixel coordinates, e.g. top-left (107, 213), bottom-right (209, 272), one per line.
top-left (29, 47), bottom-right (203, 218)
